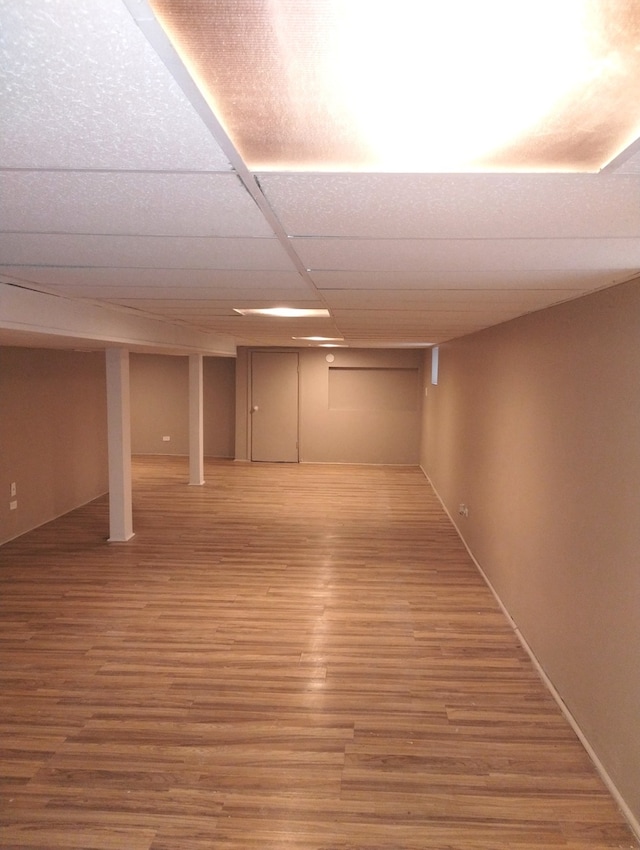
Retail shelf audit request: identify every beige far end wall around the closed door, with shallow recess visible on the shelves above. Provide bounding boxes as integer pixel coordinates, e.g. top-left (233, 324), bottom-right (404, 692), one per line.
top-left (236, 348), bottom-right (422, 464)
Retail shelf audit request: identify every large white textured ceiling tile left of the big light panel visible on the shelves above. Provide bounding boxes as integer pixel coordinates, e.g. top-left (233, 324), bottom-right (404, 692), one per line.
top-left (0, 0), bottom-right (230, 171)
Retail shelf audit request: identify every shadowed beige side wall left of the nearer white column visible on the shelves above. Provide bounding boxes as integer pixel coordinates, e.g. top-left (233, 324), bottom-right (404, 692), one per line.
top-left (0, 348), bottom-right (108, 543)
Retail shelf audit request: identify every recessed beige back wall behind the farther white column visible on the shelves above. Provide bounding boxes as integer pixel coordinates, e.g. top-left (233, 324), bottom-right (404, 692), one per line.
top-left (130, 354), bottom-right (235, 457)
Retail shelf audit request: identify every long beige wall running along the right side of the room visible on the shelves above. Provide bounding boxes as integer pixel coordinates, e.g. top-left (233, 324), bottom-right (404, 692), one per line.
top-left (421, 282), bottom-right (640, 819)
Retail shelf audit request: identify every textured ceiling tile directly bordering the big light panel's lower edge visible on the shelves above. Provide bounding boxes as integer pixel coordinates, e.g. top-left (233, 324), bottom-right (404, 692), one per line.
top-left (260, 169), bottom-right (640, 239)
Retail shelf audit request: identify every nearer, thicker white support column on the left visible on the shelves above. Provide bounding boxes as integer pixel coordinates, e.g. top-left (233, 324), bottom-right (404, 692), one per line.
top-left (105, 348), bottom-right (134, 543)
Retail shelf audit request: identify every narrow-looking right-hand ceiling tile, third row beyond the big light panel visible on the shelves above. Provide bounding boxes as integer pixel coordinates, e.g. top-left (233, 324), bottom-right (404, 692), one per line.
top-left (310, 268), bottom-right (631, 292)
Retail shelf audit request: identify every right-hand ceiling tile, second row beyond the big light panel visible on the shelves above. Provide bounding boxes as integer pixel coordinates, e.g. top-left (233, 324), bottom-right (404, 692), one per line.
top-left (292, 239), bottom-right (640, 272)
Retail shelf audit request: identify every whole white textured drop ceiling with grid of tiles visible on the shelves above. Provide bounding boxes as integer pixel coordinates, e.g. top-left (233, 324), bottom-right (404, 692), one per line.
top-left (0, 0), bottom-right (640, 347)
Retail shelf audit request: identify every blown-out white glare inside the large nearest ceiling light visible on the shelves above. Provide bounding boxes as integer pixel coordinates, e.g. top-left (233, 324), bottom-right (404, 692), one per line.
top-left (332, 0), bottom-right (597, 170)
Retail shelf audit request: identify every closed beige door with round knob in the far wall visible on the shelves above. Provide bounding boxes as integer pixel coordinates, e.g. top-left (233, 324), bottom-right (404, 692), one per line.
top-left (250, 351), bottom-right (298, 463)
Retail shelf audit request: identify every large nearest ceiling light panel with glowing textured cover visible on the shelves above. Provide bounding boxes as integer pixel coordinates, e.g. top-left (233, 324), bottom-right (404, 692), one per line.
top-left (150, 0), bottom-right (640, 172)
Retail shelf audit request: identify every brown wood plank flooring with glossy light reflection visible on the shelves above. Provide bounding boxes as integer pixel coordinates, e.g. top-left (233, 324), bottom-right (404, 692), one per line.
top-left (0, 458), bottom-right (637, 850)
